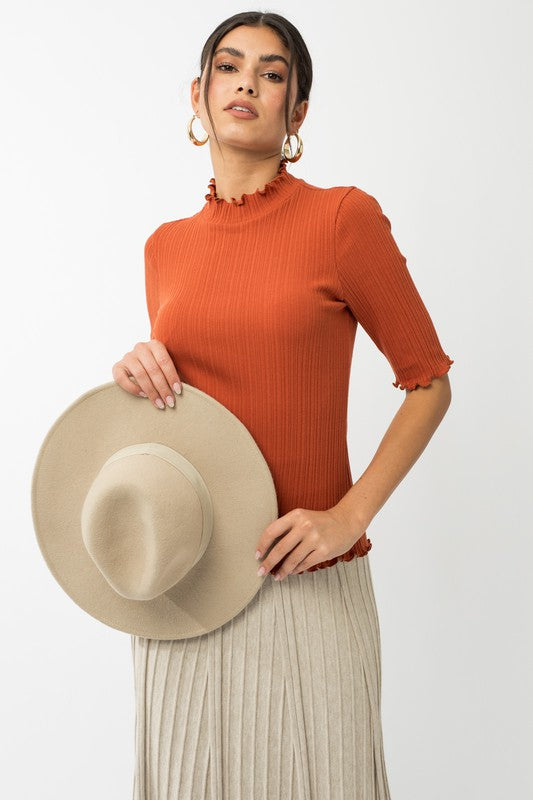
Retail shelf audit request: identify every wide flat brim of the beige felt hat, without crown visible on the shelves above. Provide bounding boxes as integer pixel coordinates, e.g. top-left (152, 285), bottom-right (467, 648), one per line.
top-left (32, 381), bottom-right (278, 639)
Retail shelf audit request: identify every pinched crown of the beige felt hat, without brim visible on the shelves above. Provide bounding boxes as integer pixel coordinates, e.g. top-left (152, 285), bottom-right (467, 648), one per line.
top-left (81, 442), bottom-right (213, 600)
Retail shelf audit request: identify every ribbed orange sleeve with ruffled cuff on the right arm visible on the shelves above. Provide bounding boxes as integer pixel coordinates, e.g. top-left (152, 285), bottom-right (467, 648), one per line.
top-left (335, 186), bottom-right (454, 390)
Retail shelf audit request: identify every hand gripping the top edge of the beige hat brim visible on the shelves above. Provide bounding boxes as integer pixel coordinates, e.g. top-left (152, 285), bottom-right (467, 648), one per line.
top-left (112, 339), bottom-right (181, 409)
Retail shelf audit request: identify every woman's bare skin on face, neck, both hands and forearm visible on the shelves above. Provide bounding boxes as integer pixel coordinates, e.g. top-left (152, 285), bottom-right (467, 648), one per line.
top-left (113, 26), bottom-right (451, 580)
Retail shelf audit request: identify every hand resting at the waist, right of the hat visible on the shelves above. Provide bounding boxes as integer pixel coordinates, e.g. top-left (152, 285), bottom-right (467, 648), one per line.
top-left (257, 506), bottom-right (365, 580)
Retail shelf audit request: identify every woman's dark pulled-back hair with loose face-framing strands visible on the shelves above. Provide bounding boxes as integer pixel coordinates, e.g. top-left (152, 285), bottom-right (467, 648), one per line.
top-left (195, 11), bottom-right (313, 159)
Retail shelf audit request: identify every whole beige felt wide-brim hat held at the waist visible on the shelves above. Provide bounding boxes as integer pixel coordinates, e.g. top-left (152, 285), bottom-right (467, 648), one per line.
top-left (32, 381), bottom-right (278, 639)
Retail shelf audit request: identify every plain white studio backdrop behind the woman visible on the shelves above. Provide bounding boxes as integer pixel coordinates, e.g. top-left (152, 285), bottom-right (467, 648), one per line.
top-left (0, 0), bottom-right (533, 800)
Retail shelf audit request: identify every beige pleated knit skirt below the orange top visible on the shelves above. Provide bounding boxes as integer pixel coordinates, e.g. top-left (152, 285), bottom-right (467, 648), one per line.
top-left (131, 555), bottom-right (390, 800)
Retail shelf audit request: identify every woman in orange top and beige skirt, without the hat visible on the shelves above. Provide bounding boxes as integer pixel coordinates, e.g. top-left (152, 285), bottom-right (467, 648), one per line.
top-left (113, 12), bottom-right (453, 800)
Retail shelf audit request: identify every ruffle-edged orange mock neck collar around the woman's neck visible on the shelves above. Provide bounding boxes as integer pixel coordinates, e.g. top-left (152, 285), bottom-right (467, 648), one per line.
top-left (199, 159), bottom-right (299, 223)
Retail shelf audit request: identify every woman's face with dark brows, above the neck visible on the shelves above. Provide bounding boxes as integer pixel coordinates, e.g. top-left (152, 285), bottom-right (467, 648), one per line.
top-left (191, 25), bottom-right (308, 153)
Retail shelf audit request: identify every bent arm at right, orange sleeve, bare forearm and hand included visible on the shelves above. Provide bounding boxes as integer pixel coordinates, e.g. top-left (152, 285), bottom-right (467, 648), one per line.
top-left (256, 192), bottom-right (454, 579)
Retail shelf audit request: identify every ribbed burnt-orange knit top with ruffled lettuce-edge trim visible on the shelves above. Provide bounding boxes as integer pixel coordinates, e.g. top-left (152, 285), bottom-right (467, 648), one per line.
top-left (144, 160), bottom-right (454, 572)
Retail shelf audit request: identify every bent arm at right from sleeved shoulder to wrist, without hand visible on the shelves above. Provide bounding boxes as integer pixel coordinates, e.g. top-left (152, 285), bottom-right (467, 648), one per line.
top-left (330, 188), bottom-right (453, 531)
